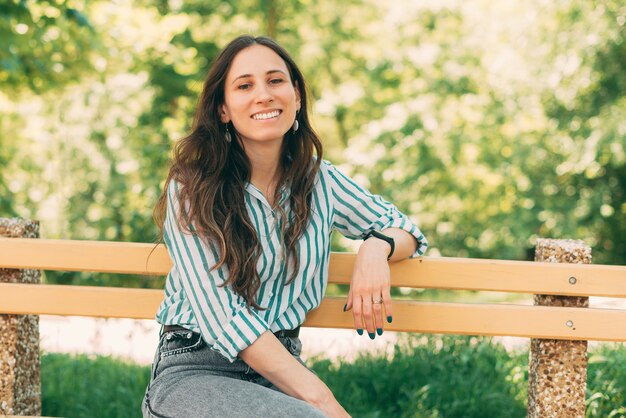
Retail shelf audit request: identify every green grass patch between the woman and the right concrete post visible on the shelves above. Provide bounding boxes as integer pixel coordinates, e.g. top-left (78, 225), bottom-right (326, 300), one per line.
top-left (312, 336), bottom-right (527, 418)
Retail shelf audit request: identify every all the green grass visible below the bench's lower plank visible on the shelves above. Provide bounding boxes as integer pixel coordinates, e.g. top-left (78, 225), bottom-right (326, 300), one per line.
top-left (41, 334), bottom-right (626, 418)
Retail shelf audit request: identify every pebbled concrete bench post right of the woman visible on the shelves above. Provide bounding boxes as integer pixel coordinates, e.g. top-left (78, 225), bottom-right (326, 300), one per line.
top-left (527, 239), bottom-right (591, 418)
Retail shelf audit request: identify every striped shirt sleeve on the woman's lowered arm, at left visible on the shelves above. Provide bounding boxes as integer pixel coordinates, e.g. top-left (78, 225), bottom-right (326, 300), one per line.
top-left (163, 180), bottom-right (270, 363)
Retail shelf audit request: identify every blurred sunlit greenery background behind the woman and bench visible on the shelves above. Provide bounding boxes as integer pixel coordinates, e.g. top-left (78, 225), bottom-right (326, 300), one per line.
top-left (0, 0), bottom-right (626, 417)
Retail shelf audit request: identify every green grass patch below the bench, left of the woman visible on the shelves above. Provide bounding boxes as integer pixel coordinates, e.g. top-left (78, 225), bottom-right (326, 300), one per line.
top-left (41, 353), bottom-right (150, 418)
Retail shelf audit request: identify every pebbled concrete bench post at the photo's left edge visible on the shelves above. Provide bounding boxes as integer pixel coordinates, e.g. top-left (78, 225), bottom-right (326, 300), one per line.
top-left (0, 218), bottom-right (41, 416)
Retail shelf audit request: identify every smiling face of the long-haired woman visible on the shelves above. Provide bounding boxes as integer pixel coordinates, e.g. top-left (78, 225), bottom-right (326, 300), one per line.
top-left (221, 45), bottom-right (300, 145)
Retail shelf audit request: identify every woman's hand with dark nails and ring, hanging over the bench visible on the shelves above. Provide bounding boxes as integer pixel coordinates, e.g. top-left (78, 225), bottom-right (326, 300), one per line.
top-left (344, 238), bottom-right (393, 339)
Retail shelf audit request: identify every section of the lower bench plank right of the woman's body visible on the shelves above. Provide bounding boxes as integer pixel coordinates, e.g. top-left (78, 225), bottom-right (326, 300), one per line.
top-left (304, 298), bottom-right (626, 341)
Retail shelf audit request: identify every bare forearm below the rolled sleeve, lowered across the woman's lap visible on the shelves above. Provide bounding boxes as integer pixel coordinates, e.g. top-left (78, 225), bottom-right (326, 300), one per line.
top-left (239, 331), bottom-right (349, 417)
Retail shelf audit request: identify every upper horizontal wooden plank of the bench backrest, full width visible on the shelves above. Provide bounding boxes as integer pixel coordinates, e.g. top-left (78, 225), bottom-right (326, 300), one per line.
top-left (0, 238), bottom-right (626, 297)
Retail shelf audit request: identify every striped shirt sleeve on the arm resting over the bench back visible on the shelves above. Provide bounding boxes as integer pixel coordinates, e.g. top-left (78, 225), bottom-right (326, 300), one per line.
top-left (324, 161), bottom-right (428, 258)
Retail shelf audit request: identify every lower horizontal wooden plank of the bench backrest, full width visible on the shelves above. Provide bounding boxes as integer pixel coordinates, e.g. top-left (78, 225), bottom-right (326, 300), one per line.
top-left (0, 283), bottom-right (626, 341)
